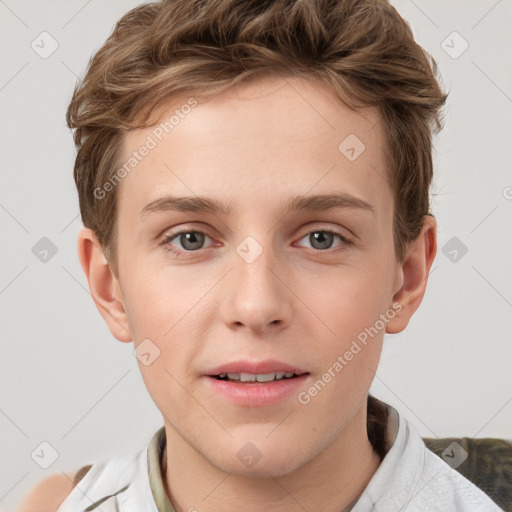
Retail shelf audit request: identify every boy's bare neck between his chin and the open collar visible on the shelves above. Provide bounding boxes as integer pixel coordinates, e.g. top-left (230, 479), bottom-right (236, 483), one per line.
top-left (162, 407), bottom-right (380, 512)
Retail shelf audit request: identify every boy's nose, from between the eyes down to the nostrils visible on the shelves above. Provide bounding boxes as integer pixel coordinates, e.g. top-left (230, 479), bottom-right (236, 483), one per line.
top-left (220, 241), bottom-right (293, 334)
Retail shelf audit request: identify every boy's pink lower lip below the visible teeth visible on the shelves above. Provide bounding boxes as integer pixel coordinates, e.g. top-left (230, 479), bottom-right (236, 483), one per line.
top-left (206, 373), bottom-right (309, 407)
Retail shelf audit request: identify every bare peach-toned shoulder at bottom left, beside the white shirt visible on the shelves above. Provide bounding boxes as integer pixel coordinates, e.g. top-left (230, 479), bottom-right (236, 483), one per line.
top-left (18, 465), bottom-right (91, 512)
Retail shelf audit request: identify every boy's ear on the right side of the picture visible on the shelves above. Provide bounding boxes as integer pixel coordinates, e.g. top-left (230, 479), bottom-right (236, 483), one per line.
top-left (386, 215), bottom-right (437, 334)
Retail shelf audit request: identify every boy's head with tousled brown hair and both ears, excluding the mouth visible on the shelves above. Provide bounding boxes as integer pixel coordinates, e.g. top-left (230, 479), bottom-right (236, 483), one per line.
top-left (67, 0), bottom-right (446, 475)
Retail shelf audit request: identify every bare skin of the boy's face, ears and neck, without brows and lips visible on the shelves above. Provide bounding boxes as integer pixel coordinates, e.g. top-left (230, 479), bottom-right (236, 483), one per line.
top-left (78, 76), bottom-right (437, 512)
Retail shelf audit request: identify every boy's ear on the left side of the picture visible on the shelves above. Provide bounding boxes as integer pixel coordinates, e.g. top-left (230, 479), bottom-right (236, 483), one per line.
top-left (78, 228), bottom-right (132, 342)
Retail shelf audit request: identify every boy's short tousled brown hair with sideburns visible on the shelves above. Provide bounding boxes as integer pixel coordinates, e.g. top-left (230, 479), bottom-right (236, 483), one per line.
top-left (66, 0), bottom-right (447, 276)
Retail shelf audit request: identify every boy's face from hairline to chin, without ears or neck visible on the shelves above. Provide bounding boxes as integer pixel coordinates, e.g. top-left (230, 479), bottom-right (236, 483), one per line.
top-left (109, 77), bottom-right (401, 476)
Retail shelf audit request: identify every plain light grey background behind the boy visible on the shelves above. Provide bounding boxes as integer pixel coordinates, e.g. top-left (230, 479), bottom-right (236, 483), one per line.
top-left (0, 0), bottom-right (512, 510)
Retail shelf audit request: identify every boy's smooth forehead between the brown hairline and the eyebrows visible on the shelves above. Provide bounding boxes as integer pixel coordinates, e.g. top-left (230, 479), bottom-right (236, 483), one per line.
top-left (118, 73), bottom-right (391, 220)
